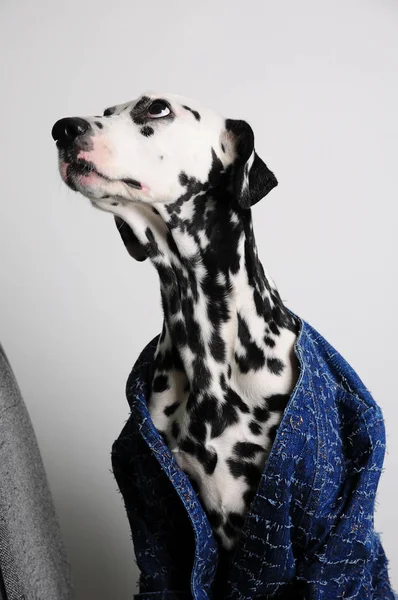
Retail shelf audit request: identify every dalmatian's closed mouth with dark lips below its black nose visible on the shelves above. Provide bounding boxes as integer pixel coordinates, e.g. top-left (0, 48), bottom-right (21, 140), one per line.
top-left (59, 159), bottom-right (145, 191)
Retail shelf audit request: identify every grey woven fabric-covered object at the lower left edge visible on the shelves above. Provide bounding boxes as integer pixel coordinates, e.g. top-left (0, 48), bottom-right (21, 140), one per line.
top-left (0, 345), bottom-right (74, 600)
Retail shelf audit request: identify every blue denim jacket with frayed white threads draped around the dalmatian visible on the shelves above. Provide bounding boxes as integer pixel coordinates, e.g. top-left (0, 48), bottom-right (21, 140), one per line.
top-left (112, 321), bottom-right (394, 600)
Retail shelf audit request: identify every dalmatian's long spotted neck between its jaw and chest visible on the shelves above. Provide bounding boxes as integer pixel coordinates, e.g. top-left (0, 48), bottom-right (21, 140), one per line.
top-left (134, 185), bottom-right (297, 396)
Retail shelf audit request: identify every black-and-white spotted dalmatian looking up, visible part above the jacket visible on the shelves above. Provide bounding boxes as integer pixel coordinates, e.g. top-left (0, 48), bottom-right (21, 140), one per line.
top-left (52, 93), bottom-right (298, 550)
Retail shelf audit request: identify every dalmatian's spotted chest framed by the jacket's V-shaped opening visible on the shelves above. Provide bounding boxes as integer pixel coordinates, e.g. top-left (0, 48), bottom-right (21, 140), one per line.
top-left (149, 356), bottom-right (290, 548)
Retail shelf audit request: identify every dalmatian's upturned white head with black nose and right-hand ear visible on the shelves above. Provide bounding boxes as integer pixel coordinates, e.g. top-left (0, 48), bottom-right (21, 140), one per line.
top-left (52, 93), bottom-right (277, 258)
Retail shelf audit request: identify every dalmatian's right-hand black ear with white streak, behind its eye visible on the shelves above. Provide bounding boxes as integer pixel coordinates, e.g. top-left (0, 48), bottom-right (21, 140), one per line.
top-left (225, 119), bottom-right (278, 208)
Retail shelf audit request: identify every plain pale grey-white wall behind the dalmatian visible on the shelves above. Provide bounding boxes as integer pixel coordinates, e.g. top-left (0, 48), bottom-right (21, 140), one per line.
top-left (0, 0), bottom-right (398, 600)
